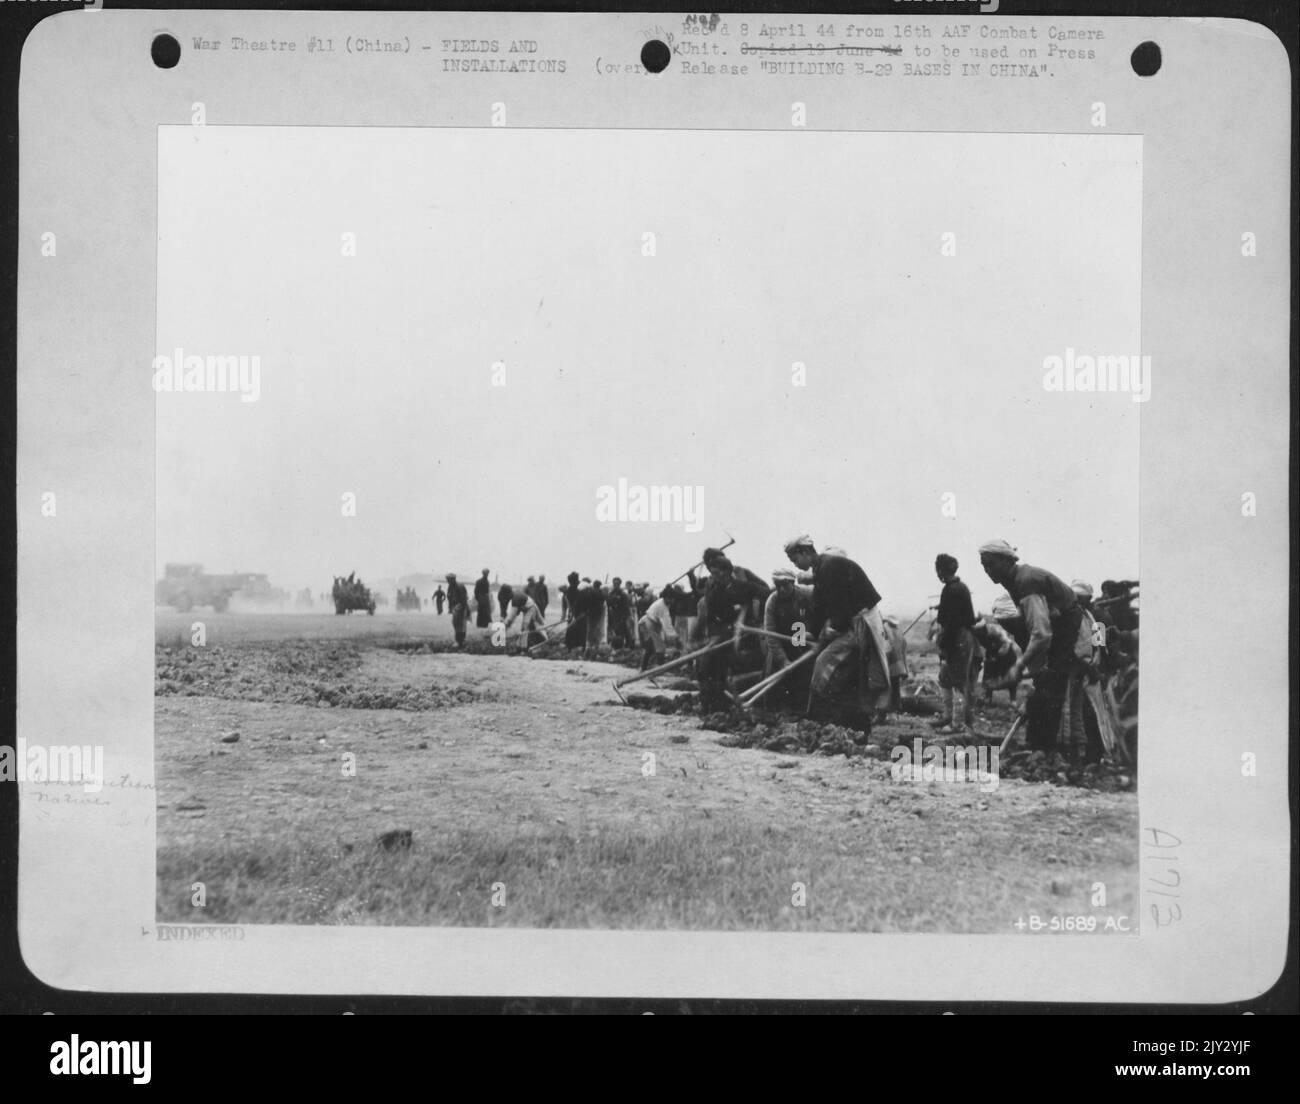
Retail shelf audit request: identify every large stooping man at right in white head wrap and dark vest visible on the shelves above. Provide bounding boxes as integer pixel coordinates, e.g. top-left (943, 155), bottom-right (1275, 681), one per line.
top-left (979, 540), bottom-right (1087, 758)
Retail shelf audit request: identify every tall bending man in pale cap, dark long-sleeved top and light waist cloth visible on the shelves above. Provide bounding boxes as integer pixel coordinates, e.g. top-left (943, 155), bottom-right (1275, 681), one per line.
top-left (785, 533), bottom-right (891, 732)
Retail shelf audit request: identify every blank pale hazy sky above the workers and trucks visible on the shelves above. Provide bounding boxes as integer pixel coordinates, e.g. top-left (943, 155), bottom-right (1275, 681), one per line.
top-left (157, 126), bottom-right (1144, 614)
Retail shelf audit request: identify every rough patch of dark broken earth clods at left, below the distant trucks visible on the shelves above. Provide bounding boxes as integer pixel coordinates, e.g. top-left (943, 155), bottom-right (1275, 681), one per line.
top-left (153, 640), bottom-right (494, 713)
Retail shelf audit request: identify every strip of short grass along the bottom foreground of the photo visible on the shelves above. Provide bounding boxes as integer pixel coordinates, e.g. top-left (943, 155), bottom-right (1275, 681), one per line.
top-left (159, 801), bottom-right (1134, 932)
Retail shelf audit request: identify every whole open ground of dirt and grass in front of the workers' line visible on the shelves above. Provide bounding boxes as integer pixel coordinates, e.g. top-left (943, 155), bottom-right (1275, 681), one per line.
top-left (155, 611), bottom-right (1138, 932)
